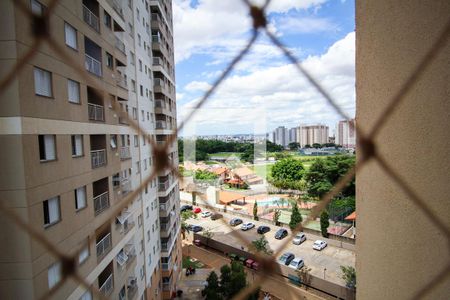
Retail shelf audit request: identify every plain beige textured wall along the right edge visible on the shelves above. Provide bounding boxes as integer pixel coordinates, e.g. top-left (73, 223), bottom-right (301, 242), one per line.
top-left (356, 0), bottom-right (450, 299)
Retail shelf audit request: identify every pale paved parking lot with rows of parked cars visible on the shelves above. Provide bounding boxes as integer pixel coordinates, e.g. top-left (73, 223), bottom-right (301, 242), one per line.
top-left (187, 213), bottom-right (355, 285)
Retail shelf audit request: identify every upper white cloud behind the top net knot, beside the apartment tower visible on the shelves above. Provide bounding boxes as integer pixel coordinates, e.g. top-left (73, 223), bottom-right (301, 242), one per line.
top-left (173, 0), bottom-right (326, 62)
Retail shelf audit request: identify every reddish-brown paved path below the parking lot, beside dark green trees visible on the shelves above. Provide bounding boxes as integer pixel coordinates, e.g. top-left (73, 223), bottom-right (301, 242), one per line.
top-left (182, 241), bottom-right (333, 300)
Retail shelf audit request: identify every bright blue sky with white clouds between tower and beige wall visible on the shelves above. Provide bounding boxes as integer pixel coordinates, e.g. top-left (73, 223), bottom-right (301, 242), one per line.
top-left (174, 0), bottom-right (355, 135)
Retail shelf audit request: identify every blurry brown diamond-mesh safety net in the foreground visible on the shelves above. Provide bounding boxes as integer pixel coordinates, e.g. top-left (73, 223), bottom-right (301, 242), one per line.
top-left (0, 0), bottom-right (450, 299)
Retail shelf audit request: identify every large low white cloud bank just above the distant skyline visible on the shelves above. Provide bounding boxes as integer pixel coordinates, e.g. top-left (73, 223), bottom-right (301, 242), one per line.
top-left (178, 32), bottom-right (355, 132)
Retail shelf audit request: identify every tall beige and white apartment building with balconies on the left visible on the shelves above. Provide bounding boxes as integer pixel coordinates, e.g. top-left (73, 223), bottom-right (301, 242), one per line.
top-left (0, 0), bottom-right (181, 300)
